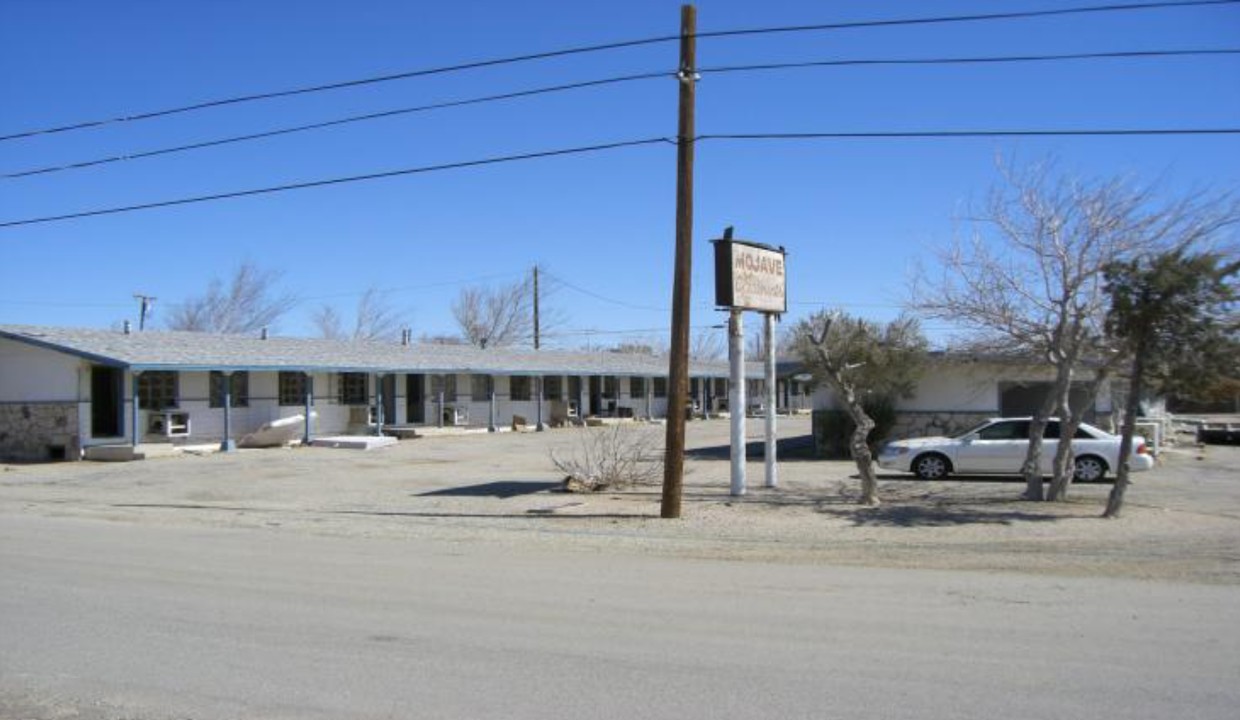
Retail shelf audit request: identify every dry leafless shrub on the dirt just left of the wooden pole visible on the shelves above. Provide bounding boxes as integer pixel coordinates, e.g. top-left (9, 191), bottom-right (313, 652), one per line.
top-left (551, 425), bottom-right (663, 492)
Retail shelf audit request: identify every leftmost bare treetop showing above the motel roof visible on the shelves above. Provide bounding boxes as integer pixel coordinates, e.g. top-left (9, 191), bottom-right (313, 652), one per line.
top-left (167, 261), bottom-right (296, 333)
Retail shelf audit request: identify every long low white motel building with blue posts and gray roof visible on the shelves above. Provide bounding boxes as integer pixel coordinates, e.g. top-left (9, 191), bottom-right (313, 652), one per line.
top-left (0, 325), bottom-right (808, 461)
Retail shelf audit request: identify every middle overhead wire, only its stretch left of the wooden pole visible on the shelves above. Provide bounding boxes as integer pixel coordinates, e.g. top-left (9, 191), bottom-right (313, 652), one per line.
top-left (0, 72), bottom-right (675, 180)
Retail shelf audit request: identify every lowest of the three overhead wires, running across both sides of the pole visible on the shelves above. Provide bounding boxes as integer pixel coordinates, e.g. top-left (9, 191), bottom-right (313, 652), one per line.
top-left (0, 128), bottom-right (1240, 228)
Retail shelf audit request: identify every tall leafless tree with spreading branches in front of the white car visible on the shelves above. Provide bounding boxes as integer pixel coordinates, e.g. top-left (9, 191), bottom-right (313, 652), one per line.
top-left (911, 162), bottom-right (1221, 499)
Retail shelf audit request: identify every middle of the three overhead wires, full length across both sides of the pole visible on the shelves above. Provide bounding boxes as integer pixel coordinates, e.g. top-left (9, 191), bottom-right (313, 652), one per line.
top-left (9, 48), bottom-right (1240, 180)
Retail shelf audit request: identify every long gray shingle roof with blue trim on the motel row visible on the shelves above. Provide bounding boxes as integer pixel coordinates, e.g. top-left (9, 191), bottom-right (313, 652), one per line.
top-left (0, 325), bottom-right (761, 378)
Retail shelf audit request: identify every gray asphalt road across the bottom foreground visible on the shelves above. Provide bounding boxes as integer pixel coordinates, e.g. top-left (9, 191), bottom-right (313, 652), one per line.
top-left (0, 513), bottom-right (1240, 720)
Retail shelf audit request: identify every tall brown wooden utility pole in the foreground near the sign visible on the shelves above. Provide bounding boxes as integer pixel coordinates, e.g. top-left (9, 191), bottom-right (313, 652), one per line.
top-left (660, 5), bottom-right (697, 518)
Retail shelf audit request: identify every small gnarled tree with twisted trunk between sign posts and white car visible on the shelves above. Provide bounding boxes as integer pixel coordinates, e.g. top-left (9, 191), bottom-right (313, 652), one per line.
top-left (794, 311), bottom-right (928, 506)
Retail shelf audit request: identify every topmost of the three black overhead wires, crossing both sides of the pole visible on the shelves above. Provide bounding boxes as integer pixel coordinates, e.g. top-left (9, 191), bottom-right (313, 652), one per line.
top-left (7, 0), bottom-right (1240, 141)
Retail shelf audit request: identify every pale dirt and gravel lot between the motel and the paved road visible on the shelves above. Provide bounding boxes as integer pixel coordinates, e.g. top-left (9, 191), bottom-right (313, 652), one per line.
top-left (0, 416), bottom-right (1240, 584)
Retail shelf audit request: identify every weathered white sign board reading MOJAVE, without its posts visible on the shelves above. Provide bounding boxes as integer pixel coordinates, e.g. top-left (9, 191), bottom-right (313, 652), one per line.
top-left (712, 235), bottom-right (787, 314)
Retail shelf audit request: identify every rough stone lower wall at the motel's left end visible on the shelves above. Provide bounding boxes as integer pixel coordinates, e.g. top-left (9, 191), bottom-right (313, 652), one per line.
top-left (0, 403), bottom-right (82, 462)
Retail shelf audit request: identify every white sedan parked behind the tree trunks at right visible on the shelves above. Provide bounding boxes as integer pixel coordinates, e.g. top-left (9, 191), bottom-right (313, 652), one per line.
top-left (878, 418), bottom-right (1154, 482)
